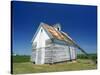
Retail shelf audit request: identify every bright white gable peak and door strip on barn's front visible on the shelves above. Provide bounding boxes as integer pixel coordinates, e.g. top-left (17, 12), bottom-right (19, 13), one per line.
top-left (31, 27), bottom-right (50, 64)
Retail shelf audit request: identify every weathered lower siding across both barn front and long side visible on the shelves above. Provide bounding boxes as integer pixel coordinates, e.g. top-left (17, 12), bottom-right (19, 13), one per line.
top-left (32, 39), bottom-right (76, 64)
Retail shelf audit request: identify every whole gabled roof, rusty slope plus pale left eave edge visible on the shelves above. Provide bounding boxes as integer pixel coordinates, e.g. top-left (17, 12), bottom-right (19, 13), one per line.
top-left (32, 22), bottom-right (74, 44)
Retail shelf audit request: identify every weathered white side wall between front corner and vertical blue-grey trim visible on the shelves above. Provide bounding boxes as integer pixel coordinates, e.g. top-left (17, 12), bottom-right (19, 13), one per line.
top-left (53, 44), bottom-right (70, 62)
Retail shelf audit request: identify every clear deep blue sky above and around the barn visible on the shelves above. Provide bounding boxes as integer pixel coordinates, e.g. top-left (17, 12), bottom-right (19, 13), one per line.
top-left (12, 1), bottom-right (97, 54)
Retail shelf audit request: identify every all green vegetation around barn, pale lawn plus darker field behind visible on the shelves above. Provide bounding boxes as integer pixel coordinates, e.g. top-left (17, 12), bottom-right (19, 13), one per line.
top-left (12, 54), bottom-right (97, 74)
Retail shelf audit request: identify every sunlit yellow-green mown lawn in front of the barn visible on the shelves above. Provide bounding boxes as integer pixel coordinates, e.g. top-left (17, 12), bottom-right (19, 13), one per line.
top-left (13, 59), bottom-right (97, 74)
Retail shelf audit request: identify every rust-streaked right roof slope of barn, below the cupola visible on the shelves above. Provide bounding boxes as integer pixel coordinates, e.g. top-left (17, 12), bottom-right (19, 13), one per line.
top-left (42, 23), bottom-right (73, 44)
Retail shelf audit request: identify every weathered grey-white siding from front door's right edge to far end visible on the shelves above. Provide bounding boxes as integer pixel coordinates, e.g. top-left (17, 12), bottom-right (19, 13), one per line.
top-left (45, 44), bottom-right (75, 63)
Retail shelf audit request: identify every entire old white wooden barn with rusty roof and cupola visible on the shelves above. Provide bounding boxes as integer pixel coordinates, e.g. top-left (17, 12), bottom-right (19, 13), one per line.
top-left (31, 23), bottom-right (77, 64)
